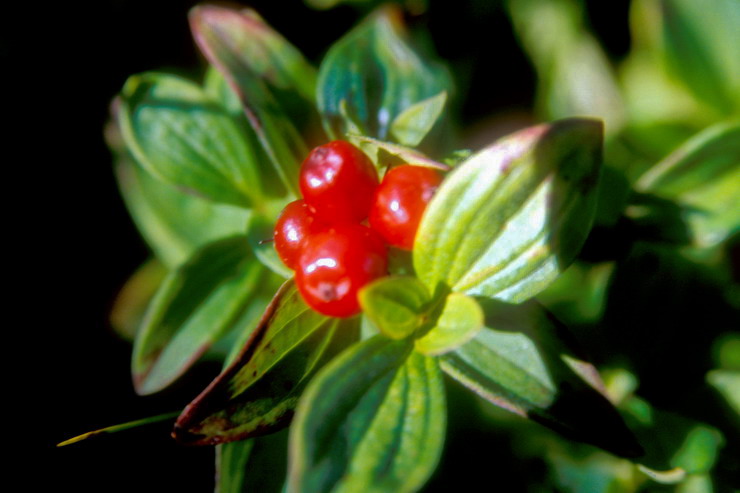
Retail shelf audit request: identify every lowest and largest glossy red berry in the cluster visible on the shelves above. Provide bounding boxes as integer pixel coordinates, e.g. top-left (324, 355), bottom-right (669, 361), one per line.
top-left (295, 224), bottom-right (388, 317)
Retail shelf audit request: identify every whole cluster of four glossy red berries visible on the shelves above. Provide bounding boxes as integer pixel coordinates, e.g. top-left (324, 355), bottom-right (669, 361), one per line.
top-left (274, 140), bottom-right (442, 317)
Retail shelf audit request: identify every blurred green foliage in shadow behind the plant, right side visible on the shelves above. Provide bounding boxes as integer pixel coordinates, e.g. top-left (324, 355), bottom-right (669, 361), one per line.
top-left (492, 0), bottom-right (740, 493)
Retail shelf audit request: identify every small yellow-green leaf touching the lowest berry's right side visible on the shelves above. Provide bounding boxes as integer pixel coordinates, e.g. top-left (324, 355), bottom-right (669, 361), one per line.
top-left (359, 276), bottom-right (431, 339)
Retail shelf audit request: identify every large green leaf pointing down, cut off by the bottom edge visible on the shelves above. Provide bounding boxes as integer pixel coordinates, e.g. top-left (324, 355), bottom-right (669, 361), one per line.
top-left (288, 336), bottom-right (446, 493)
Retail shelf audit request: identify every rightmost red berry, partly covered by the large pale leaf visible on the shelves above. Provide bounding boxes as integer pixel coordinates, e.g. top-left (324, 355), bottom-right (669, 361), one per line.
top-left (370, 164), bottom-right (442, 250)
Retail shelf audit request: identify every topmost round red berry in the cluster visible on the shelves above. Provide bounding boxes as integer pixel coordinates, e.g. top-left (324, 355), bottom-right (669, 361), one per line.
top-left (299, 140), bottom-right (378, 224)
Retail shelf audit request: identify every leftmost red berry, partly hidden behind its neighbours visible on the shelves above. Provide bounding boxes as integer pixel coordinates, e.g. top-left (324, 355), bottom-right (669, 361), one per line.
top-left (273, 199), bottom-right (325, 270)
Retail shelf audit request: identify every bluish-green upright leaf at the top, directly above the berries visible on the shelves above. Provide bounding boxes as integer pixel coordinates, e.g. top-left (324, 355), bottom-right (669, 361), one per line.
top-left (317, 7), bottom-right (449, 140)
